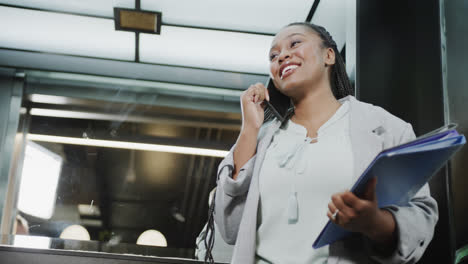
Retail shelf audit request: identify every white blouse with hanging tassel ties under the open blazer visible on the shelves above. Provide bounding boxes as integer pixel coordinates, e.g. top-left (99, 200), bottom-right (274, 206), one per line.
top-left (256, 101), bottom-right (353, 264)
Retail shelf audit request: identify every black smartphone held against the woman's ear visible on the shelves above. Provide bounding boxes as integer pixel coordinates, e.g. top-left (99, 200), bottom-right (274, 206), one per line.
top-left (264, 78), bottom-right (293, 123)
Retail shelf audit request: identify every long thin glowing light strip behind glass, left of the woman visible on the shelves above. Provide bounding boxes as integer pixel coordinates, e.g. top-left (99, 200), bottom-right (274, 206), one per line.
top-left (27, 134), bottom-right (228, 157)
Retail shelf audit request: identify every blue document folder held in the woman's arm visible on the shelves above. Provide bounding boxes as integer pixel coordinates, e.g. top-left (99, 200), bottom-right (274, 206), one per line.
top-left (312, 125), bottom-right (466, 248)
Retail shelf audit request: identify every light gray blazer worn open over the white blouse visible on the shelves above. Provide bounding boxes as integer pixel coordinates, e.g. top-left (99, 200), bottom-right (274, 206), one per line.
top-left (215, 96), bottom-right (438, 264)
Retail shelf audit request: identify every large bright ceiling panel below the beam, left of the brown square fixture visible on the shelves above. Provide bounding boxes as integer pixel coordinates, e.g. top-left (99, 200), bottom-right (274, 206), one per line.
top-left (0, 7), bottom-right (135, 61)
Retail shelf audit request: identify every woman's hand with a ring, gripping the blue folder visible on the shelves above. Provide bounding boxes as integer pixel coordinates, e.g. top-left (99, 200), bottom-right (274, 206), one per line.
top-left (327, 178), bottom-right (396, 245)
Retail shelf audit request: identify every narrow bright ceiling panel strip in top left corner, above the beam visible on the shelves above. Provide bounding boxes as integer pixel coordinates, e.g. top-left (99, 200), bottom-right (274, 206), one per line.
top-left (0, 0), bottom-right (135, 17)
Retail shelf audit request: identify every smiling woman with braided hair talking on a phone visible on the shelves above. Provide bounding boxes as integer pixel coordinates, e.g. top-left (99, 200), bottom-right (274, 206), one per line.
top-left (215, 23), bottom-right (438, 264)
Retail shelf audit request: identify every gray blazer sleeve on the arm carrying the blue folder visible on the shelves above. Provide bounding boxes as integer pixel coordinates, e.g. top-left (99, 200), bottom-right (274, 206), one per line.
top-left (366, 124), bottom-right (438, 264)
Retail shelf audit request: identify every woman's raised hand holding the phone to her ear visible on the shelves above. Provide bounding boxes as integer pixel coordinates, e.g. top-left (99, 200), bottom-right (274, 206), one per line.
top-left (241, 83), bottom-right (270, 130)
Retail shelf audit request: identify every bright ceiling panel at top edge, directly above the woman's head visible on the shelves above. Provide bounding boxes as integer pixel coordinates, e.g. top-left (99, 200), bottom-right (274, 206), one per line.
top-left (141, 0), bottom-right (312, 34)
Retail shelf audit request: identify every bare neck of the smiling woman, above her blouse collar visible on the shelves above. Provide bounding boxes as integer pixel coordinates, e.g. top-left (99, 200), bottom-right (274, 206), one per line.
top-left (292, 87), bottom-right (341, 134)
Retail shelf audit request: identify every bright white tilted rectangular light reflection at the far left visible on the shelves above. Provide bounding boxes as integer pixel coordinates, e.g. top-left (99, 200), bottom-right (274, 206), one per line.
top-left (18, 142), bottom-right (62, 219)
